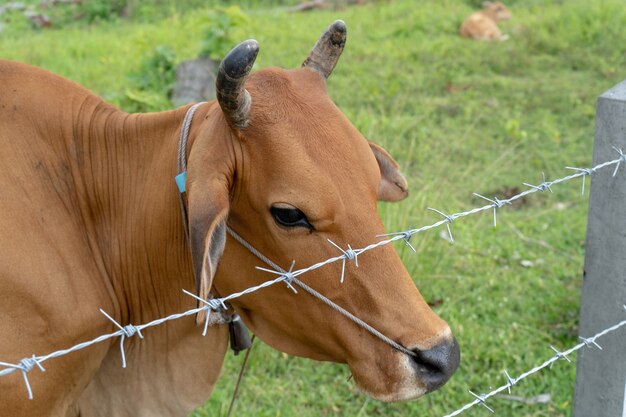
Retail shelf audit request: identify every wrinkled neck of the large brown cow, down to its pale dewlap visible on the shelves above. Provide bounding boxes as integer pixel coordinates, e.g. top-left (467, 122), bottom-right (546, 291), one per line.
top-left (60, 97), bottom-right (234, 417)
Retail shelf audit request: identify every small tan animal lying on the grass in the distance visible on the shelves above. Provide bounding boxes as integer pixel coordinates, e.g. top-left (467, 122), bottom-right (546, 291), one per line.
top-left (459, 1), bottom-right (511, 41)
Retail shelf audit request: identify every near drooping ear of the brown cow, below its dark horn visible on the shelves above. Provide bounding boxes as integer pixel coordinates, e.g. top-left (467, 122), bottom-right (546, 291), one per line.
top-left (187, 178), bottom-right (230, 323)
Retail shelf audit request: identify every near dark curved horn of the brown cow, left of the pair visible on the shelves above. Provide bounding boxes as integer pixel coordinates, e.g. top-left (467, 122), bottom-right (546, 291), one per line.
top-left (215, 39), bottom-right (259, 129)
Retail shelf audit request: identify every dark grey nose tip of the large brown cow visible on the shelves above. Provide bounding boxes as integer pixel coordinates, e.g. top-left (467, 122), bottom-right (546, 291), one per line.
top-left (413, 337), bottom-right (461, 391)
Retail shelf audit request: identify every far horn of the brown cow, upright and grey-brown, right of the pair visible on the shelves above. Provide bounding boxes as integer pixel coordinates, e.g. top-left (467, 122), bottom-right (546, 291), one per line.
top-left (302, 20), bottom-right (347, 78)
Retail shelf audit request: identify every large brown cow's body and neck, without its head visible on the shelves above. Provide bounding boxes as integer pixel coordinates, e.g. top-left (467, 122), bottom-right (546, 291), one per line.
top-left (0, 62), bottom-right (227, 417)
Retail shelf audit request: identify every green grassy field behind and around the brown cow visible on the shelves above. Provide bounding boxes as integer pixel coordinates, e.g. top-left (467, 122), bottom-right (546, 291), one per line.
top-left (0, 0), bottom-right (626, 417)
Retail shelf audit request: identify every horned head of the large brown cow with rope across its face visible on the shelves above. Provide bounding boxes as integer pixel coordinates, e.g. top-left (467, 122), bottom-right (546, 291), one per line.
top-left (187, 21), bottom-right (459, 401)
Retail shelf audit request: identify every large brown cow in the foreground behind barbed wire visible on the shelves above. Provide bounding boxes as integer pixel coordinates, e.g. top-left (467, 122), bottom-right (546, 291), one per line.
top-left (0, 21), bottom-right (459, 417)
